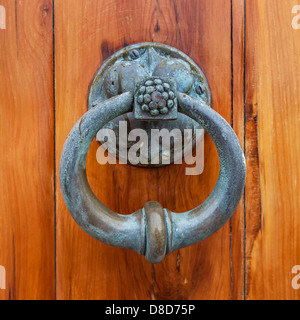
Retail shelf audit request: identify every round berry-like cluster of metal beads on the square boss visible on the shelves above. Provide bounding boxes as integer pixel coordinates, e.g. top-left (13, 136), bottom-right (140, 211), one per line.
top-left (137, 78), bottom-right (175, 116)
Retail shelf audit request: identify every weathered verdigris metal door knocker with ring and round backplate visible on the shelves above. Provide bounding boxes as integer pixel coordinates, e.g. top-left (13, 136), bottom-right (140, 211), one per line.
top-left (59, 43), bottom-right (246, 263)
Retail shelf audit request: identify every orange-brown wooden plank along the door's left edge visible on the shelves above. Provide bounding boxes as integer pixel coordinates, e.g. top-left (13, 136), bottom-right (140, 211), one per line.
top-left (0, 0), bottom-right (55, 299)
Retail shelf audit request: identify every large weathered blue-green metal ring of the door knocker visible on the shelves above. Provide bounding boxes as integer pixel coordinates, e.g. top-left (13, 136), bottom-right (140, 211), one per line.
top-left (59, 44), bottom-right (246, 263)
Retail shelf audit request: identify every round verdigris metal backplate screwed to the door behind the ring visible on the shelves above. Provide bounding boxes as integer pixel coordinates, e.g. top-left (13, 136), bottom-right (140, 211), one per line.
top-left (88, 43), bottom-right (211, 167)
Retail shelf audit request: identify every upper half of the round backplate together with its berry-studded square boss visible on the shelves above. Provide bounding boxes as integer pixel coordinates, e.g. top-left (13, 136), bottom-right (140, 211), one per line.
top-left (93, 44), bottom-right (210, 121)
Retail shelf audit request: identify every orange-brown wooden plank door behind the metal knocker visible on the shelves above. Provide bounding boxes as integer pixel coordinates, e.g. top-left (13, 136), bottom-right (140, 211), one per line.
top-left (0, 0), bottom-right (300, 299)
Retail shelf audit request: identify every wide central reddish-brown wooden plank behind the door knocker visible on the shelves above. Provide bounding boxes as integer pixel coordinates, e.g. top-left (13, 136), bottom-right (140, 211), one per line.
top-left (55, 0), bottom-right (232, 299)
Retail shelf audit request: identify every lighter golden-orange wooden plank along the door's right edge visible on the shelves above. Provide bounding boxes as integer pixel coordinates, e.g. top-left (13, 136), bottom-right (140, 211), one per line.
top-left (245, 0), bottom-right (300, 299)
